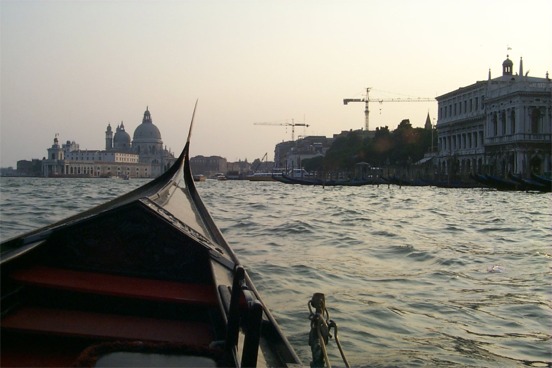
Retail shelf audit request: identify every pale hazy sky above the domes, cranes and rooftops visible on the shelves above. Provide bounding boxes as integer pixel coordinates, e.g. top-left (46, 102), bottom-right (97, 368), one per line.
top-left (0, 0), bottom-right (552, 166)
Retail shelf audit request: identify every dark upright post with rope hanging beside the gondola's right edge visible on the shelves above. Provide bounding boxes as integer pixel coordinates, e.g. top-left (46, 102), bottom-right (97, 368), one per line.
top-left (308, 293), bottom-right (350, 368)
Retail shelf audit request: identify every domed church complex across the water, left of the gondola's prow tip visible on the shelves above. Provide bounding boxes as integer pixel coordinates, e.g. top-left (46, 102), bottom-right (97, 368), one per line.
top-left (42, 108), bottom-right (175, 178)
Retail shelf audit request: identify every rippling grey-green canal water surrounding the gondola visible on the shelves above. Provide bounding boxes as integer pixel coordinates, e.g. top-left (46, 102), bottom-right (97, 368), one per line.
top-left (0, 178), bottom-right (552, 367)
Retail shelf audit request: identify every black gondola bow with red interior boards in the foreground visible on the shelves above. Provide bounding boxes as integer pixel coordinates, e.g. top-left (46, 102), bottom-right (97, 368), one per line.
top-left (0, 105), bottom-right (300, 367)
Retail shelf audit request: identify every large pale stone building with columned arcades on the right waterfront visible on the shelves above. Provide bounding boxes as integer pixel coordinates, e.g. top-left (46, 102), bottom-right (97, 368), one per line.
top-left (436, 58), bottom-right (552, 177)
